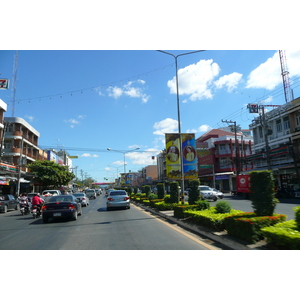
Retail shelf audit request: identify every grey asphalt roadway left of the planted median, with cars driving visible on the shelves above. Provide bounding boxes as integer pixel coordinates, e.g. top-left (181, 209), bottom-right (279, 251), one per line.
top-left (0, 195), bottom-right (220, 250)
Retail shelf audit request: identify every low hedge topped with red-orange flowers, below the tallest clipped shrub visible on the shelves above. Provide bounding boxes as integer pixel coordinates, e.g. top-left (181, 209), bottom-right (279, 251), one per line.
top-left (224, 212), bottom-right (286, 244)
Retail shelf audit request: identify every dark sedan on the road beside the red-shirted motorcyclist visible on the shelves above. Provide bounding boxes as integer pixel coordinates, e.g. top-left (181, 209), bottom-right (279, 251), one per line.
top-left (42, 195), bottom-right (82, 223)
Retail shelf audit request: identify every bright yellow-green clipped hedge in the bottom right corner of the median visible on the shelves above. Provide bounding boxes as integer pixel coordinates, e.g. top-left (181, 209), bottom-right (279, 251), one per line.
top-left (261, 220), bottom-right (300, 250)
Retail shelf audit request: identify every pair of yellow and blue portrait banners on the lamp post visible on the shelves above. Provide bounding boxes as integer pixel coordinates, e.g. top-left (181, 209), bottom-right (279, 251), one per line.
top-left (165, 133), bottom-right (198, 180)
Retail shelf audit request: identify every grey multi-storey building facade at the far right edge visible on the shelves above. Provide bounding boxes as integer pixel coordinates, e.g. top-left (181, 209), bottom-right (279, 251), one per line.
top-left (247, 98), bottom-right (300, 189)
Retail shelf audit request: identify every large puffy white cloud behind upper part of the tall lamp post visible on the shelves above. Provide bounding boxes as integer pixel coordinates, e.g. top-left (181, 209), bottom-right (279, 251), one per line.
top-left (167, 59), bottom-right (220, 102)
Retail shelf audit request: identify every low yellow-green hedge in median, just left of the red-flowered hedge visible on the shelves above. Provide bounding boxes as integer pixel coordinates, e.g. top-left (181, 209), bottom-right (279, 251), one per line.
top-left (184, 207), bottom-right (242, 231)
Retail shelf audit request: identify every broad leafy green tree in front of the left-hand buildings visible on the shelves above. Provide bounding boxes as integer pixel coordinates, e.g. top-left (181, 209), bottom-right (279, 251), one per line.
top-left (28, 160), bottom-right (75, 188)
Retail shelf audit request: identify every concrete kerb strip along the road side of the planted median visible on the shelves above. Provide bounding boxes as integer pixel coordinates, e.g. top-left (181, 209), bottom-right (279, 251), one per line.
top-left (131, 202), bottom-right (267, 250)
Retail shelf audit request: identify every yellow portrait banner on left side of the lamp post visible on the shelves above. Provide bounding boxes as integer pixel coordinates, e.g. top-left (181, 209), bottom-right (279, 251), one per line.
top-left (165, 133), bottom-right (182, 180)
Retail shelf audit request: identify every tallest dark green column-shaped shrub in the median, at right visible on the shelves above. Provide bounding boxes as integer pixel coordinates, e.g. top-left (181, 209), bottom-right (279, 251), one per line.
top-left (250, 171), bottom-right (278, 216)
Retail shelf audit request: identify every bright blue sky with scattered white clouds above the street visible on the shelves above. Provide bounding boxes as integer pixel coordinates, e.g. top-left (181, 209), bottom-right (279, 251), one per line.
top-left (0, 50), bottom-right (300, 182)
